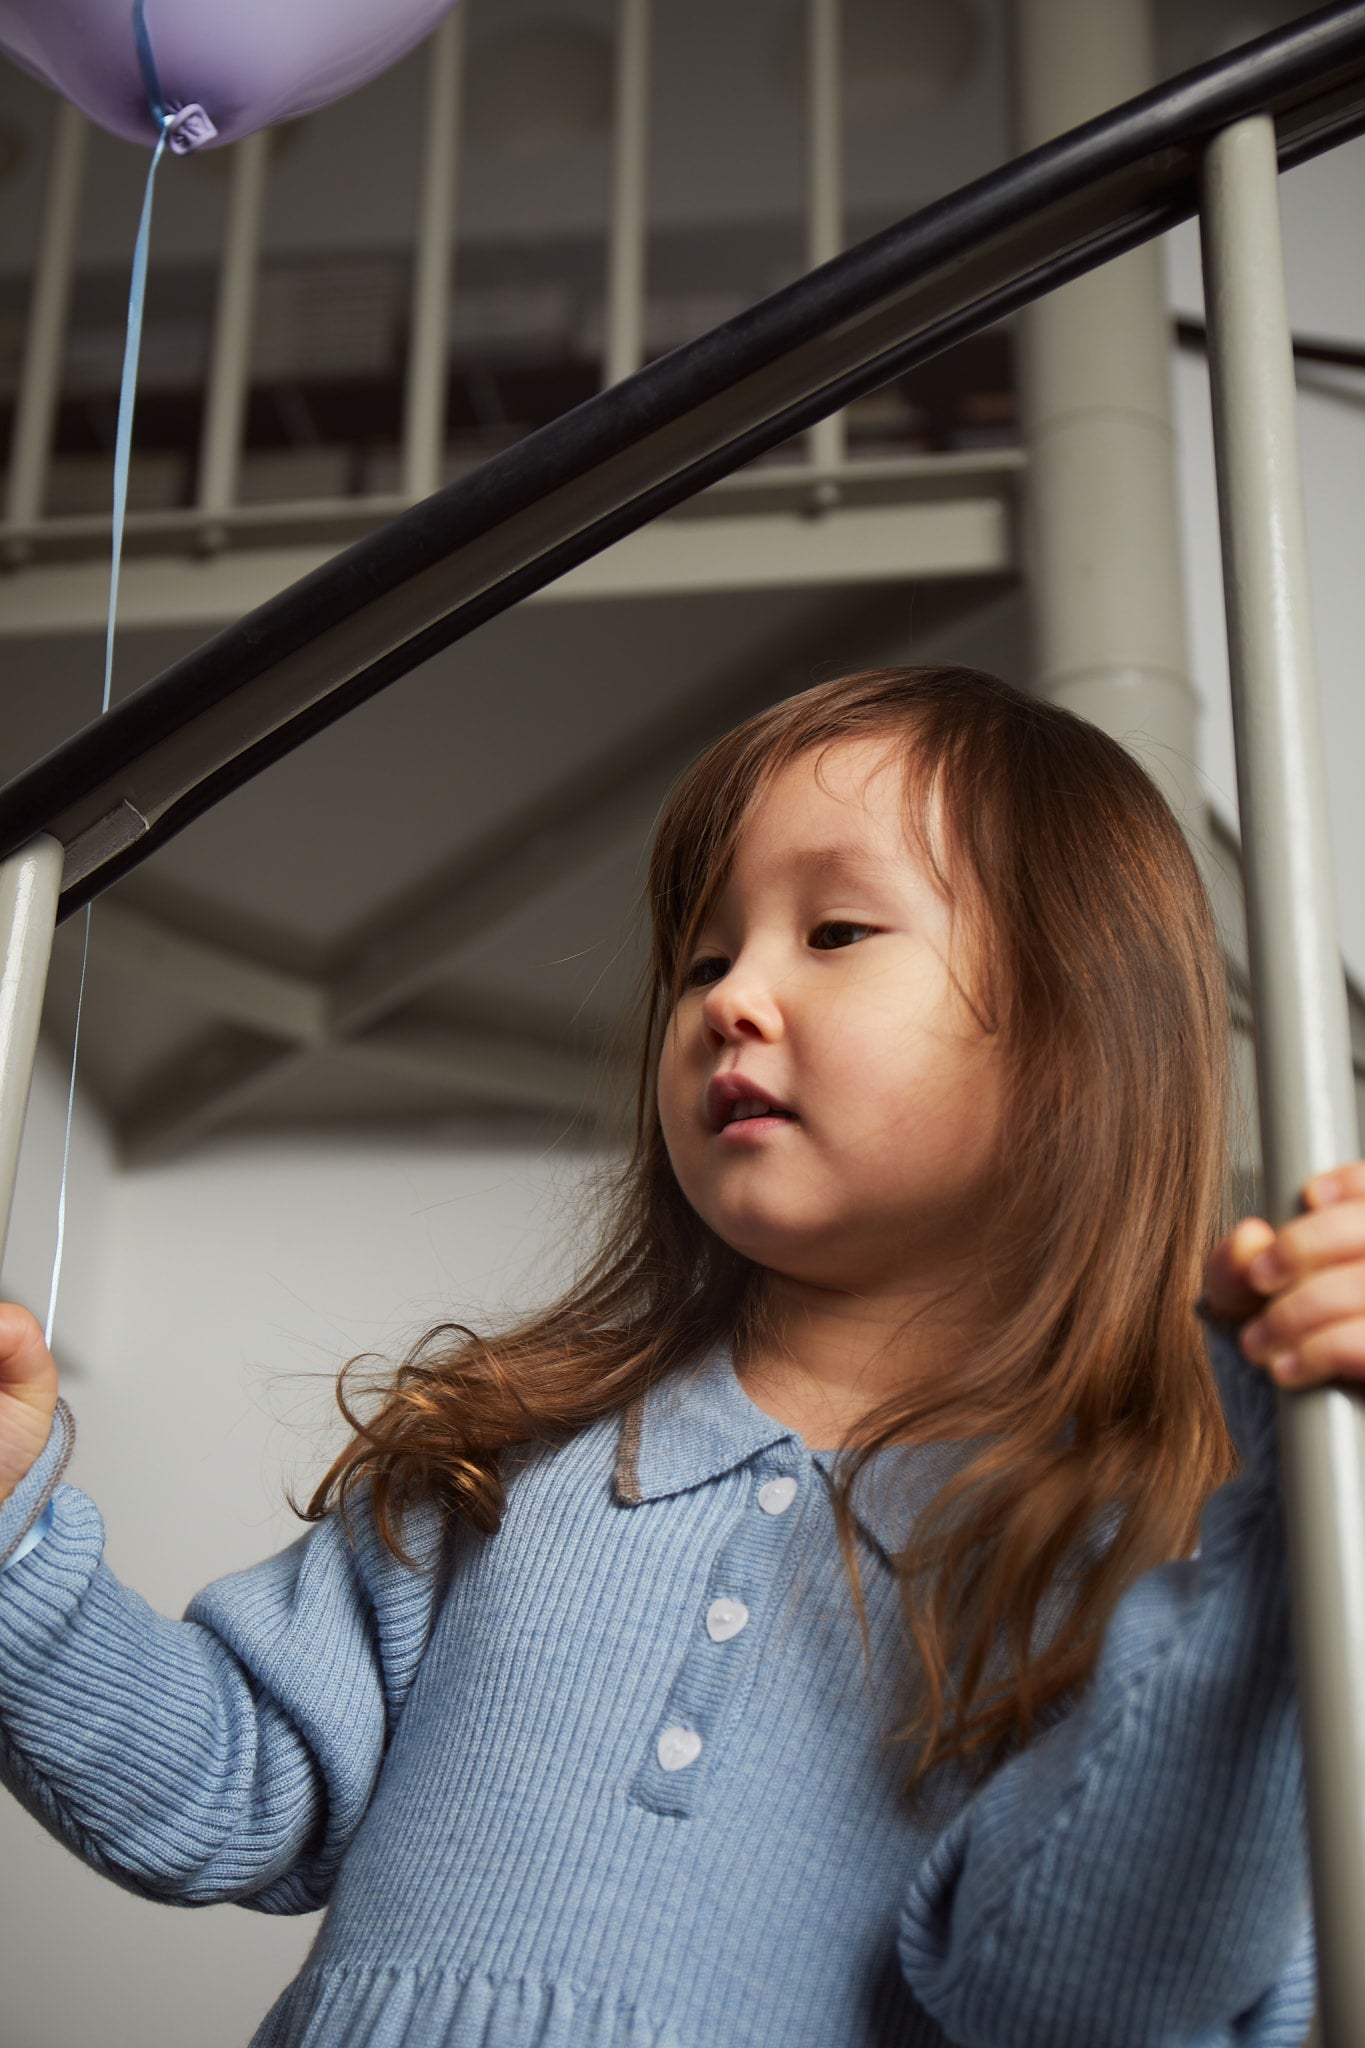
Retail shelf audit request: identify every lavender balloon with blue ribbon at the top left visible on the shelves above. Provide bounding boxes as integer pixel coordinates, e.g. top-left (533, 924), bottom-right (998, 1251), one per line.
top-left (0, 0), bottom-right (464, 156)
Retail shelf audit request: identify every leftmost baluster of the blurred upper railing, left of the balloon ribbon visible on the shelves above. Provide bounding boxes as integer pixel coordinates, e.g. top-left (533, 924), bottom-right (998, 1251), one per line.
top-left (4, 100), bottom-right (90, 559)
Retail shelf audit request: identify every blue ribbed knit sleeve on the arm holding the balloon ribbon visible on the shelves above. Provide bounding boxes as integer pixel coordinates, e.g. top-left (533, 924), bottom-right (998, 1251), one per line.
top-left (0, 1425), bottom-right (454, 1913)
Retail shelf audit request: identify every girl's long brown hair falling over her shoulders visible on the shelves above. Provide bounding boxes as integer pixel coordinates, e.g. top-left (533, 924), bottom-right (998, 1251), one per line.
top-left (299, 668), bottom-right (1238, 1802)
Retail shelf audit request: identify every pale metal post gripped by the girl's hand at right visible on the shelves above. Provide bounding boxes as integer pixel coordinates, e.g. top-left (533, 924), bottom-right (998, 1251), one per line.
top-left (1201, 115), bottom-right (1365, 2048)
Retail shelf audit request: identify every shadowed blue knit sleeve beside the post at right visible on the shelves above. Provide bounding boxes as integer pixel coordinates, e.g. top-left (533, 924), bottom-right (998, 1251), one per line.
top-left (898, 1315), bottom-right (1314, 2048)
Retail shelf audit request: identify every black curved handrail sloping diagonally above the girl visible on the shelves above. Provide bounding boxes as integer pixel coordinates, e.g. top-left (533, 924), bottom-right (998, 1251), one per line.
top-left (0, 0), bottom-right (1365, 918)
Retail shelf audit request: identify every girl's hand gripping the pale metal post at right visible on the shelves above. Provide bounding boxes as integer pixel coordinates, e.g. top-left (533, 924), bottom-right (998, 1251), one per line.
top-left (1203, 1159), bottom-right (1365, 1386)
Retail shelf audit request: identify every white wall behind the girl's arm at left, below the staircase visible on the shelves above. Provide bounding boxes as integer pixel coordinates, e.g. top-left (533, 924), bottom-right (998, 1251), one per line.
top-left (0, 1053), bottom-right (609, 2048)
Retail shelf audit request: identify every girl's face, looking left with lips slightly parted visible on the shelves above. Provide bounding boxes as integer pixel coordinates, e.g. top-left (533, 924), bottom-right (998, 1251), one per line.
top-left (659, 737), bottom-right (1003, 1292)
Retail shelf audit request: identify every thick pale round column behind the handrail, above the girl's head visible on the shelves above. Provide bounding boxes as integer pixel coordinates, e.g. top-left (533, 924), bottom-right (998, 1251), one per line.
top-left (1013, 0), bottom-right (1205, 834)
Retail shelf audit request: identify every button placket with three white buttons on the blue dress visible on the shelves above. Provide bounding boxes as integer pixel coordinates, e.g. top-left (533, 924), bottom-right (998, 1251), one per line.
top-left (628, 1446), bottom-right (802, 1819)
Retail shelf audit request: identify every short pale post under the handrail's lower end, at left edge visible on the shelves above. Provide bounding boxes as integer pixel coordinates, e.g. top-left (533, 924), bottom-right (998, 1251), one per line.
top-left (0, 831), bottom-right (65, 1260)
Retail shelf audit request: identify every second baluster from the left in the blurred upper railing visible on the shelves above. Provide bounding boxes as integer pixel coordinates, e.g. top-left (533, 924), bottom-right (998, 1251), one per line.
top-left (196, 129), bottom-right (270, 543)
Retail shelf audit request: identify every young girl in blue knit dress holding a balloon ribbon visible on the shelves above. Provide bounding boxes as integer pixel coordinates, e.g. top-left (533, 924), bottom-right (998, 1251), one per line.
top-left (0, 668), bottom-right (1365, 2048)
